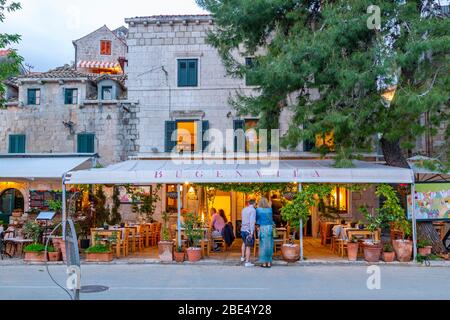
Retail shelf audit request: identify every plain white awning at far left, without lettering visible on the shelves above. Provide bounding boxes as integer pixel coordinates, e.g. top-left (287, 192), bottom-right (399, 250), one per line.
top-left (0, 154), bottom-right (93, 181)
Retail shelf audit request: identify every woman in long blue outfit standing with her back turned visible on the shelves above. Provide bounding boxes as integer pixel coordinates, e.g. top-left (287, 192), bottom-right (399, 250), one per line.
top-left (256, 197), bottom-right (273, 268)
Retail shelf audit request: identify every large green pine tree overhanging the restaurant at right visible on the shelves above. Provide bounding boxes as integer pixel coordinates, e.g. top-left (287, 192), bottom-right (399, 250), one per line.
top-left (197, 0), bottom-right (450, 167)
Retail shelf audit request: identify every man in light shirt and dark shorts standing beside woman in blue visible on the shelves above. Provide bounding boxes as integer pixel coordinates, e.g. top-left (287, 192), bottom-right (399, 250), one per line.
top-left (241, 200), bottom-right (256, 267)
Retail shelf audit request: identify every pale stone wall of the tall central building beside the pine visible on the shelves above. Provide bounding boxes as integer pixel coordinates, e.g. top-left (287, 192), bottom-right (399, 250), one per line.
top-left (126, 15), bottom-right (298, 154)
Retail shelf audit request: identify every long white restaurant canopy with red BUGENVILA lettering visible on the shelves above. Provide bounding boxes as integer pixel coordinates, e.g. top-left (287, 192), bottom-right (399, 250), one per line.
top-left (66, 160), bottom-right (414, 185)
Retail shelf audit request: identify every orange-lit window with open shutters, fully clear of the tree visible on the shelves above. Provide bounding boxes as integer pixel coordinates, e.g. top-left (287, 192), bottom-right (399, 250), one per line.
top-left (165, 120), bottom-right (209, 153)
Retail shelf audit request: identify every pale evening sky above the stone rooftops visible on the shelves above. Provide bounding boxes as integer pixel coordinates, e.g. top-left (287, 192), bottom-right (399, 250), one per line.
top-left (1, 0), bottom-right (206, 71)
